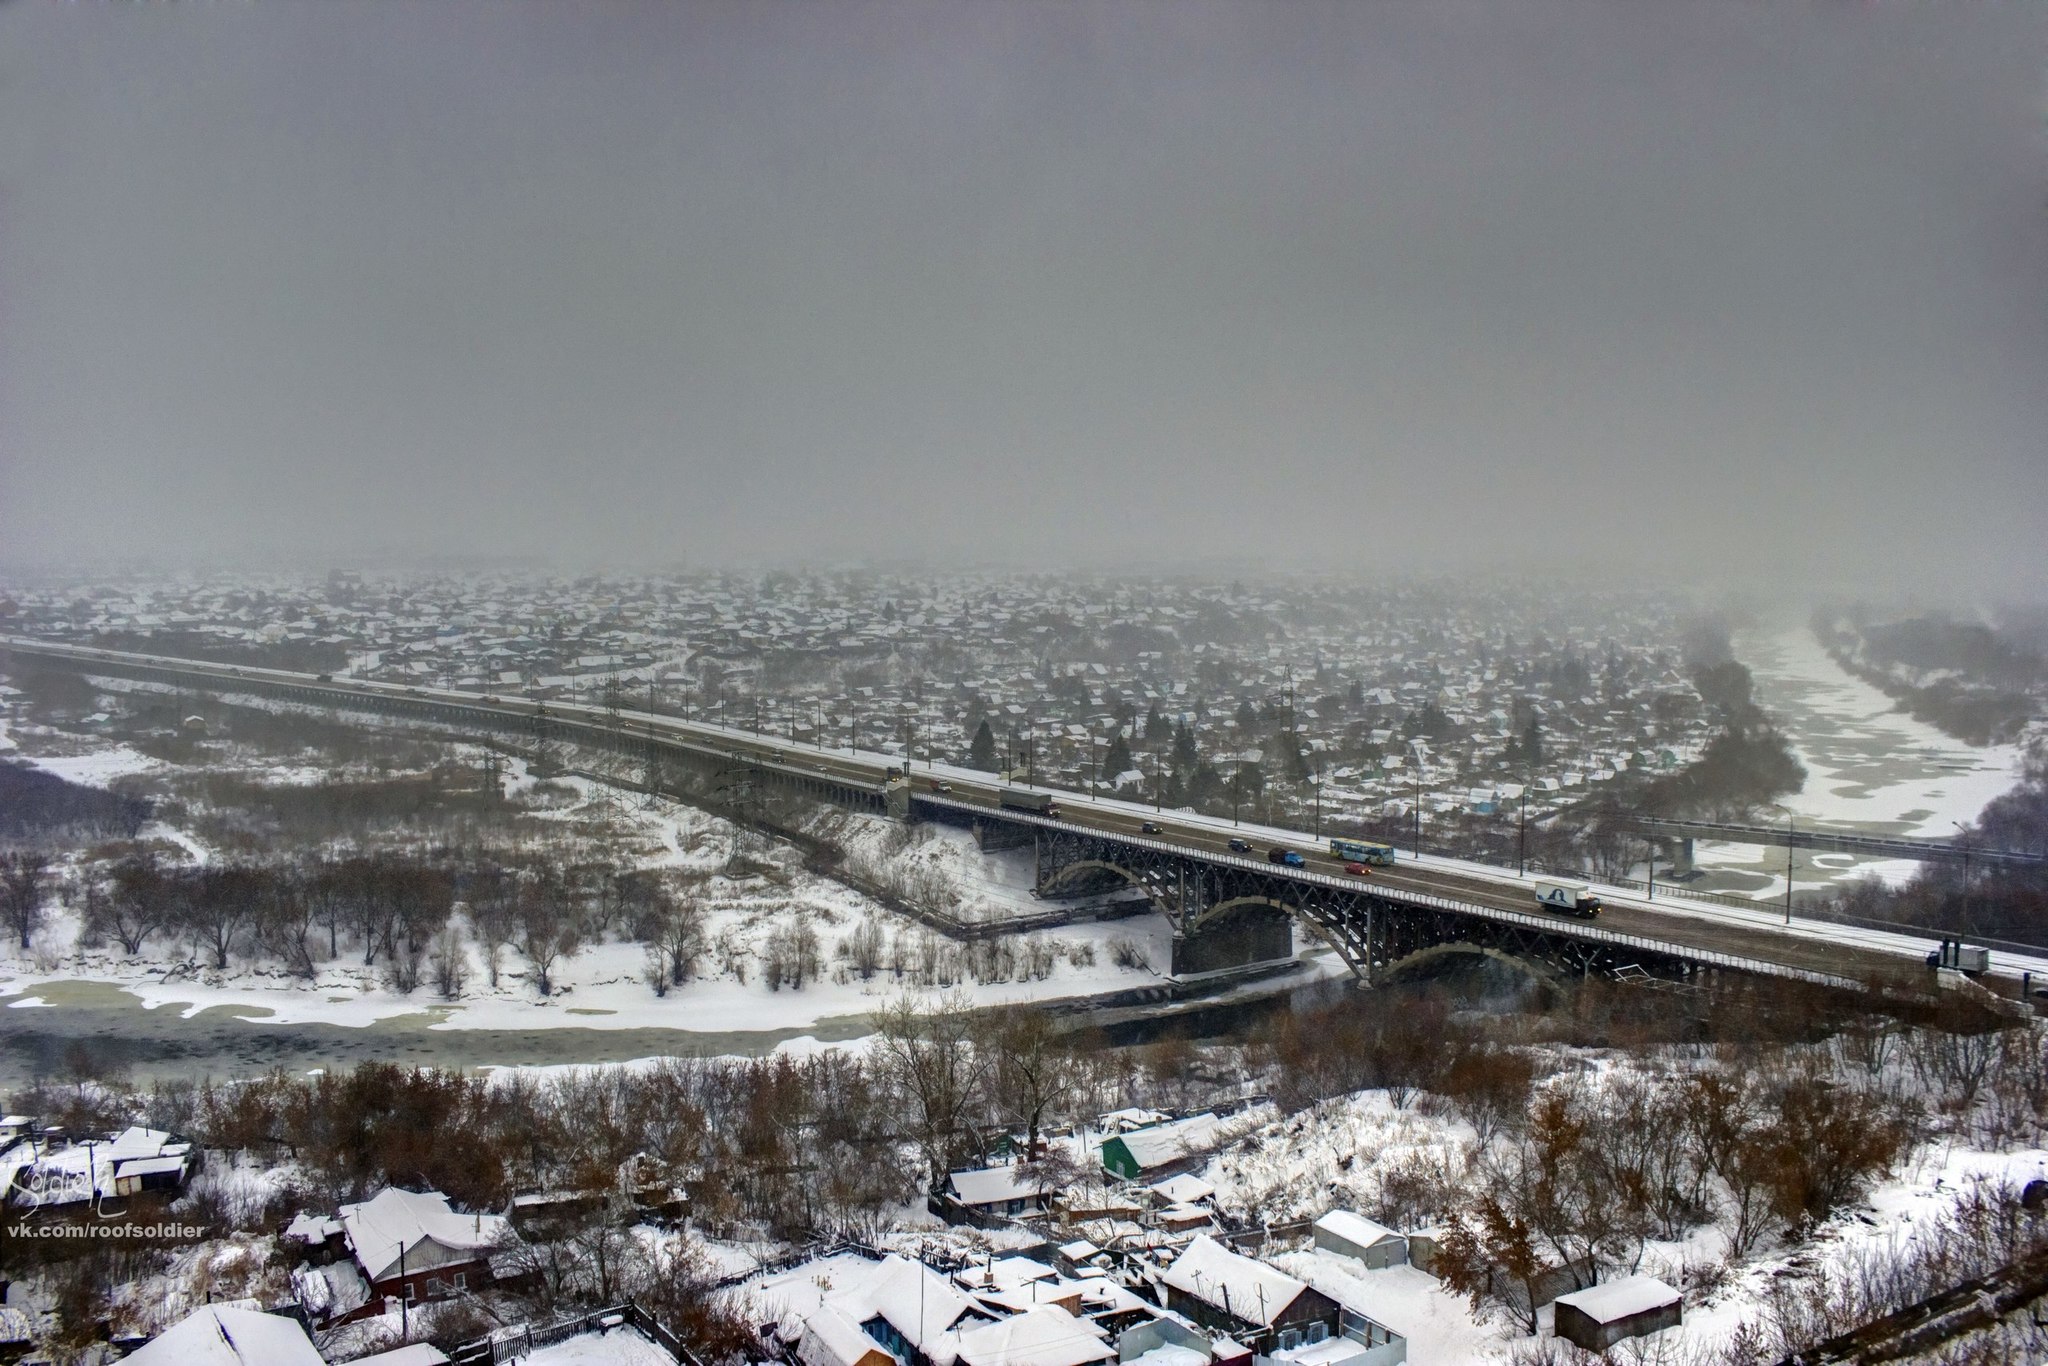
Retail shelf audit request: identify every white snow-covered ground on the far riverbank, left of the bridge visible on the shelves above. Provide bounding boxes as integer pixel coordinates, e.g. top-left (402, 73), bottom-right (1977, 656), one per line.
top-left (0, 712), bottom-right (1171, 1047)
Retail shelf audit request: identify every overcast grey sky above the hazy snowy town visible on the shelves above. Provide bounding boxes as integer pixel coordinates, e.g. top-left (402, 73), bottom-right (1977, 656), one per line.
top-left (0, 0), bottom-right (2048, 594)
